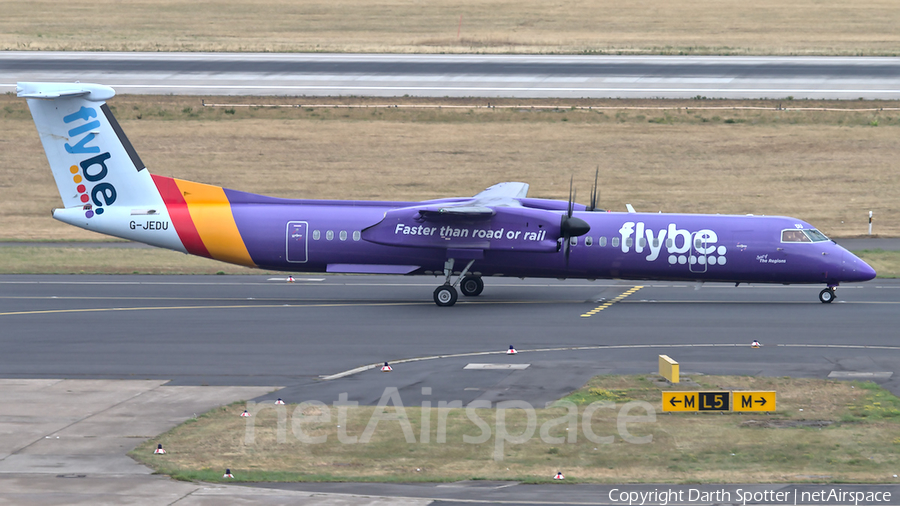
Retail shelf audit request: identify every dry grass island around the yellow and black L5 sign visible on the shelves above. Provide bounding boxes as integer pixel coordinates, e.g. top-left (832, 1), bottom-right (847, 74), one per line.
top-left (132, 376), bottom-right (900, 483)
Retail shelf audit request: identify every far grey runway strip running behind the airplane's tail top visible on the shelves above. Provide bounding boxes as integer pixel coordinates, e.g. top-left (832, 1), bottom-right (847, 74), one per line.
top-left (0, 51), bottom-right (900, 100)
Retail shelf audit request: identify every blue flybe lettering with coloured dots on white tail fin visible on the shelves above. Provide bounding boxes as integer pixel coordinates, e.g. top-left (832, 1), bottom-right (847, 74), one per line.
top-left (63, 106), bottom-right (116, 218)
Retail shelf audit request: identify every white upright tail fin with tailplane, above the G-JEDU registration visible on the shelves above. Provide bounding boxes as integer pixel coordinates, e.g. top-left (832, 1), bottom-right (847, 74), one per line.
top-left (16, 83), bottom-right (162, 214)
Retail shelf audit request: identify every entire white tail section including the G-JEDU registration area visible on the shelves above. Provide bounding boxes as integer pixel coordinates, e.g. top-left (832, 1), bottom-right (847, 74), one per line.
top-left (16, 83), bottom-right (186, 251)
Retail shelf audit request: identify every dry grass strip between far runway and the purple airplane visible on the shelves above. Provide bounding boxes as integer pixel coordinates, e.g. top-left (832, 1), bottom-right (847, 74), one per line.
top-left (0, 96), bottom-right (900, 240)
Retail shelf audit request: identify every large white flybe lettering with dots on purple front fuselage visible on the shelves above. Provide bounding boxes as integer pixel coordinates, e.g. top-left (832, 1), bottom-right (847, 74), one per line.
top-left (619, 221), bottom-right (727, 264)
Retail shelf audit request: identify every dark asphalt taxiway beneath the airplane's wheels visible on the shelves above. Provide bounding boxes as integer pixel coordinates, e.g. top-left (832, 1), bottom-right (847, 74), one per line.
top-left (0, 275), bottom-right (900, 406)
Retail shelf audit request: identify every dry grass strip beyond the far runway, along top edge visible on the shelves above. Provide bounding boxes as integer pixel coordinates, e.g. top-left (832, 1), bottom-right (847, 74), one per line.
top-left (0, 0), bottom-right (900, 55)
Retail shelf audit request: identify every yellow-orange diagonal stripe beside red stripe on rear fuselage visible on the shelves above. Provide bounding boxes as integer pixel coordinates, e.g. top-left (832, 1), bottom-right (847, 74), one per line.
top-left (175, 179), bottom-right (256, 267)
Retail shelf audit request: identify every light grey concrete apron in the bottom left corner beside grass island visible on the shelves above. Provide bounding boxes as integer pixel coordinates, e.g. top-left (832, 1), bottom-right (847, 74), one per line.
top-left (0, 379), bottom-right (428, 505)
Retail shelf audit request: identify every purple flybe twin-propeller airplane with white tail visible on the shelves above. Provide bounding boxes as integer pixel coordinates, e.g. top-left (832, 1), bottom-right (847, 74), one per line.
top-left (16, 82), bottom-right (875, 307)
